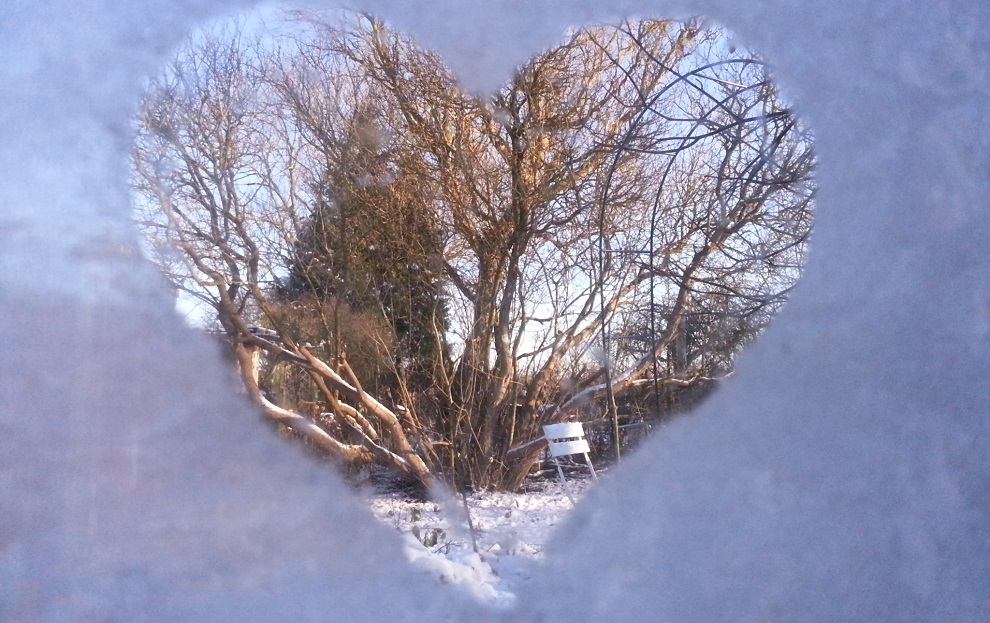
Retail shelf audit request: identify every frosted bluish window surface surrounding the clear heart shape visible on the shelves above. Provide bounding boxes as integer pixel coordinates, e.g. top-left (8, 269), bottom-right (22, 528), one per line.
top-left (0, 0), bottom-right (990, 621)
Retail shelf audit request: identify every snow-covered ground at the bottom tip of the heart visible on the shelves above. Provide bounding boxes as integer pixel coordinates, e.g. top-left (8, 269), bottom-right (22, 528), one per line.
top-left (369, 478), bottom-right (595, 607)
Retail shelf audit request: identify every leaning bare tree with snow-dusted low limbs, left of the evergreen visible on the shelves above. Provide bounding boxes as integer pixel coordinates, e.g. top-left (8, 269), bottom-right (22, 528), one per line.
top-left (134, 18), bottom-right (433, 485)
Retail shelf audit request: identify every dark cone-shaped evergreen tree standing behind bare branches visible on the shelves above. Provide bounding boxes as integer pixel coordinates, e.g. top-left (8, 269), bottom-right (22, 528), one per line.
top-left (282, 103), bottom-right (447, 390)
